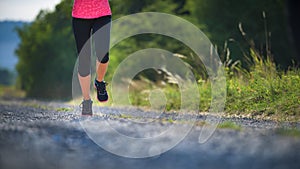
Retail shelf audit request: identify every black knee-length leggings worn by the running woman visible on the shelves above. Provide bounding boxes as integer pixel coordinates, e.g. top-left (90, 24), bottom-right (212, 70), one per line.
top-left (72, 16), bottom-right (111, 77)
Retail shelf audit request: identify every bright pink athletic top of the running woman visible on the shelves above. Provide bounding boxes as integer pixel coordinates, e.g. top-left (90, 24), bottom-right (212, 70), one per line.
top-left (72, 0), bottom-right (111, 19)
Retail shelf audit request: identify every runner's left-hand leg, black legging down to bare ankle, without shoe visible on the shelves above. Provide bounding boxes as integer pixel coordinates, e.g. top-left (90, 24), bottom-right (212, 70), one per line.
top-left (72, 18), bottom-right (92, 100)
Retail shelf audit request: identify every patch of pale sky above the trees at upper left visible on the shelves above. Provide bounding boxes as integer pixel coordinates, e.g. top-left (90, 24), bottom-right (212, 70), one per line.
top-left (0, 0), bottom-right (61, 21)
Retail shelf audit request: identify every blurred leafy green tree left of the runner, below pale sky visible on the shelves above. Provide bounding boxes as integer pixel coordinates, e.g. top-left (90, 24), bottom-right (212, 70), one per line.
top-left (16, 0), bottom-right (76, 99)
